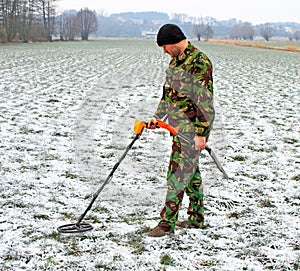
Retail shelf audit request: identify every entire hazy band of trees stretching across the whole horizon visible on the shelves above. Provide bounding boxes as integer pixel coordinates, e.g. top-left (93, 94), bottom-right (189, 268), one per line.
top-left (0, 0), bottom-right (300, 42)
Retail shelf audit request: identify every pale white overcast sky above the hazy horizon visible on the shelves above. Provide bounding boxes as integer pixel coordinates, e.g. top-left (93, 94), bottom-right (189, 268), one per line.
top-left (58, 0), bottom-right (300, 24)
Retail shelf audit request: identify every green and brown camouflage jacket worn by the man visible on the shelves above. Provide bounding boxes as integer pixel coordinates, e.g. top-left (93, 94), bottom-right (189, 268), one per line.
top-left (154, 42), bottom-right (215, 138)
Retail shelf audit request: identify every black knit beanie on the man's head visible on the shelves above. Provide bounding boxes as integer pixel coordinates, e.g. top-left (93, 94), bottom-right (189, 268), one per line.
top-left (156, 24), bottom-right (186, 46)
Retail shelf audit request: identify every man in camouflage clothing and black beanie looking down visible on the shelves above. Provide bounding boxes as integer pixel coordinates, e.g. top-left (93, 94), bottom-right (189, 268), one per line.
top-left (148, 24), bottom-right (214, 237)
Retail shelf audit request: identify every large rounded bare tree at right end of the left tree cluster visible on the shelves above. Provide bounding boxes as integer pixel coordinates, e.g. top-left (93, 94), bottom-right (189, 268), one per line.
top-left (77, 8), bottom-right (98, 40)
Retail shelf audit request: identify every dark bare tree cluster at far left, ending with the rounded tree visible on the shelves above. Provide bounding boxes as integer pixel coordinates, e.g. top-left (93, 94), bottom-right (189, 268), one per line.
top-left (0, 0), bottom-right (98, 42)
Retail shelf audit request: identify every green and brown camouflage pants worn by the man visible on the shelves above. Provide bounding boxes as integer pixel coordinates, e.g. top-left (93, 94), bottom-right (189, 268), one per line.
top-left (160, 136), bottom-right (204, 231)
